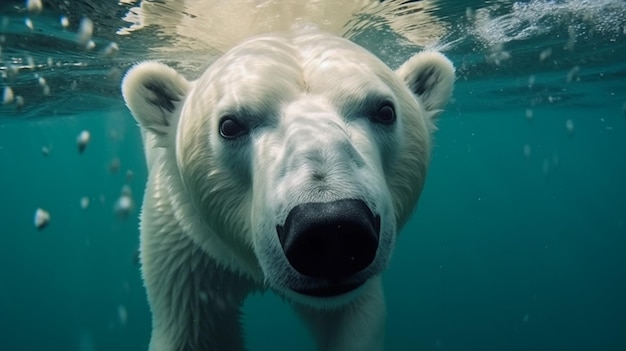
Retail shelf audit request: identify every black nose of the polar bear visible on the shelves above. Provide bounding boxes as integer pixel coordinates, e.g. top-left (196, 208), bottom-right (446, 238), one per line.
top-left (276, 199), bottom-right (380, 281)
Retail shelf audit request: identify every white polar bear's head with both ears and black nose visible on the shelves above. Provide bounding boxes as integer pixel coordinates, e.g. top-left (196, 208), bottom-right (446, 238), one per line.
top-left (123, 33), bottom-right (454, 306)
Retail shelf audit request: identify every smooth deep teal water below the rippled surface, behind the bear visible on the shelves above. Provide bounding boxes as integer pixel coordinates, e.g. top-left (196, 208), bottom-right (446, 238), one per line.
top-left (0, 96), bottom-right (626, 351)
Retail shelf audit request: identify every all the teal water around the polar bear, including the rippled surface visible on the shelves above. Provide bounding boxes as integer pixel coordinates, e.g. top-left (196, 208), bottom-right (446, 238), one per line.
top-left (0, 1), bottom-right (626, 351)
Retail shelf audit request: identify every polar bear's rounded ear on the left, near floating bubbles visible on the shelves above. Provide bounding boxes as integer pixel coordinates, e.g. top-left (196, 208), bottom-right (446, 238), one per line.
top-left (122, 62), bottom-right (191, 135)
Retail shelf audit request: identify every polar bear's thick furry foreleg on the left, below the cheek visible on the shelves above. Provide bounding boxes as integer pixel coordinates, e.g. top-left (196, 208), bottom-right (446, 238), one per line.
top-left (141, 201), bottom-right (253, 351)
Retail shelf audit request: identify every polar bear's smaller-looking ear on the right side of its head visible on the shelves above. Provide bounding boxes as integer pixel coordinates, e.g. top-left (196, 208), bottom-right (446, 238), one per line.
top-left (396, 51), bottom-right (454, 116)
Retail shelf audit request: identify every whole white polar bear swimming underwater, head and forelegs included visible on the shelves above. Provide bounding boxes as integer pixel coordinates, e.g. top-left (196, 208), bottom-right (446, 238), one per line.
top-left (122, 14), bottom-right (454, 351)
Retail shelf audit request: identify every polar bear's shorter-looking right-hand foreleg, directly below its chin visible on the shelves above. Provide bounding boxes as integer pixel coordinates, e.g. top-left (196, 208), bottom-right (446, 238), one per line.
top-left (294, 277), bottom-right (387, 351)
